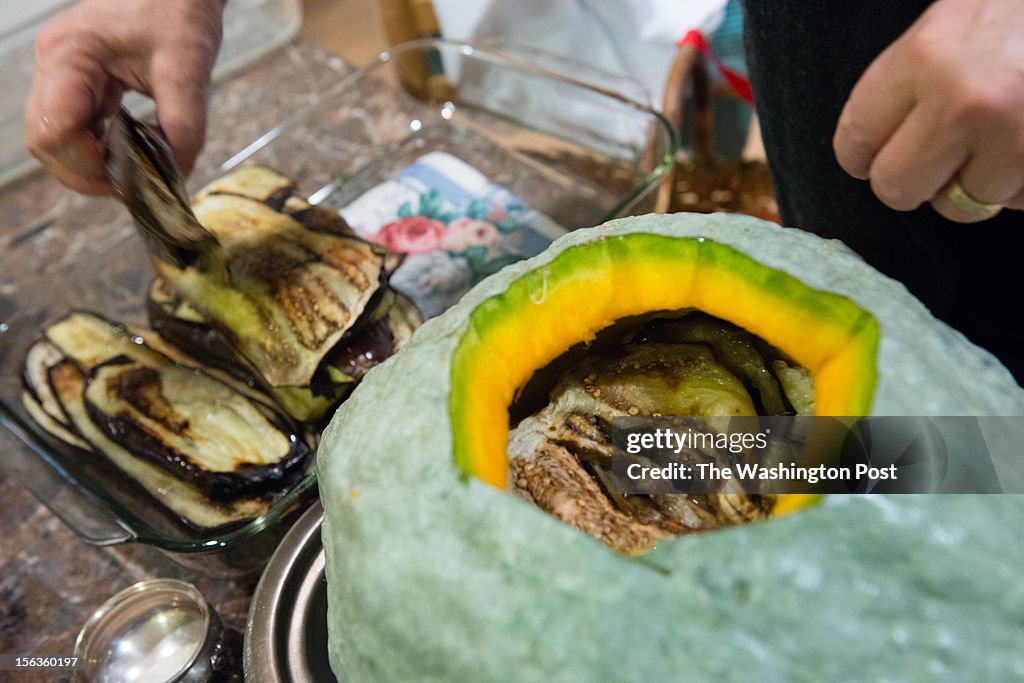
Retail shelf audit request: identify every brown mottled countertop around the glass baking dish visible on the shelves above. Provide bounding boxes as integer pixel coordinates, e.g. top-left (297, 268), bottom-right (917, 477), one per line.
top-left (0, 42), bottom-right (348, 682)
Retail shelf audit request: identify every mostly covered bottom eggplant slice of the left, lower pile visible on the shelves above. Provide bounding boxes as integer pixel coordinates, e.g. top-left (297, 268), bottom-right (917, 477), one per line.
top-left (50, 359), bottom-right (270, 528)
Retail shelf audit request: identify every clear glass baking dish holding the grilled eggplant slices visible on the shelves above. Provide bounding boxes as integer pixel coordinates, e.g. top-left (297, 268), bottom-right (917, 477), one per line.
top-left (0, 40), bottom-right (676, 575)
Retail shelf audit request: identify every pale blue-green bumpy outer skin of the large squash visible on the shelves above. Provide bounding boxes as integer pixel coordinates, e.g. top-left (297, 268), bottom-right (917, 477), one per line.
top-left (317, 214), bottom-right (1024, 681)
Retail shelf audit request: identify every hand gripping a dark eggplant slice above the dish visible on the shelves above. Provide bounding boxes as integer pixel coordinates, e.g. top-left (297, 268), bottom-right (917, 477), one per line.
top-left (25, 0), bottom-right (224, 195)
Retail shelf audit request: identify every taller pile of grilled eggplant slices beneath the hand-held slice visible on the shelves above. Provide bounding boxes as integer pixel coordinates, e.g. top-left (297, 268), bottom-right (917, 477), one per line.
top-left (147, 167), bottom-right (422, 421)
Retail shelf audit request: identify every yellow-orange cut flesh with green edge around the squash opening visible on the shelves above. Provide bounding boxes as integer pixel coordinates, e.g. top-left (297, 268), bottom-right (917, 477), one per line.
top-left (449, 232), bottom-right (880, 491)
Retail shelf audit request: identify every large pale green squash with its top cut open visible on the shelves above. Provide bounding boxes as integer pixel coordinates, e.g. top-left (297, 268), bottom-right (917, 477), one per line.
top-left (317, 214), bottom-right (1024, 681)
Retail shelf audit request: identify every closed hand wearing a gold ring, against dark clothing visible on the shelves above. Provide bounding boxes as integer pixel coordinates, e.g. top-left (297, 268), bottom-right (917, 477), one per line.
top-left (834, 0), bottom-right (1024, 222)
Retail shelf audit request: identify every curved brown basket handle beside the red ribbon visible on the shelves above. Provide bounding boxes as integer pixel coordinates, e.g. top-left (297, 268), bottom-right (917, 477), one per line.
top-left (654, 43), bottom-right (715, 213)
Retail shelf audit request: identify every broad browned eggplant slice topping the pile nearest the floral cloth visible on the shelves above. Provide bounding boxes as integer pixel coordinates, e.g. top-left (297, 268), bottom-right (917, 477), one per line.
top-left (154, 179), bottom-right (395, 387)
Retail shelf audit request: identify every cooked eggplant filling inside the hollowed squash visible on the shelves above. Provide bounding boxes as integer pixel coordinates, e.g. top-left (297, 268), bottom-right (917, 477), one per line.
top-left (508, 311), bottom-right (814, 554)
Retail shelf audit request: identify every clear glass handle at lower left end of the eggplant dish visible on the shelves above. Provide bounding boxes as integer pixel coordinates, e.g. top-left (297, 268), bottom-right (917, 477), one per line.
top-left (0, 401), bottom-right (136, 546)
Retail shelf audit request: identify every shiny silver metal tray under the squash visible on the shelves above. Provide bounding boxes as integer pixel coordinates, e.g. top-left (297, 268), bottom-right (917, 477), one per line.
top-left (244, 501), bottom-right (337, 683)
